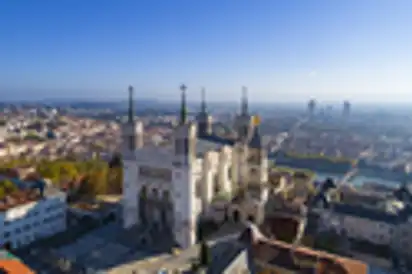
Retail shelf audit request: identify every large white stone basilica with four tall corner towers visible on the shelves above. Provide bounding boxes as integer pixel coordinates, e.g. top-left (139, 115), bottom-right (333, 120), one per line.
top-left (122, 85), bottom-right (268, 248)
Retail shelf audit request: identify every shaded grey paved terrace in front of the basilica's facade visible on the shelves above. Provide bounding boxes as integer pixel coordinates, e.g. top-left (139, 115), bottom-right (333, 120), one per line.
top-left (21, 223), bottom-right (167, 273)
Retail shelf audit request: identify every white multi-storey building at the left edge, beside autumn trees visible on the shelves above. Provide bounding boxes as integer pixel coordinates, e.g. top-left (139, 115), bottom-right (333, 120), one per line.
top-left (0, 185), bottom-right (67, 249)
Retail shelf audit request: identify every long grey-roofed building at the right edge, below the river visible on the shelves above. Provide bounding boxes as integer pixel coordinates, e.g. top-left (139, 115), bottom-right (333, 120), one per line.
top-left (311, 181), bottom-right (412, 258)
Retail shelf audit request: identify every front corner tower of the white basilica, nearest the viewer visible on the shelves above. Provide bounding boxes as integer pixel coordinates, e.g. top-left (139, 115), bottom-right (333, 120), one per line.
top-left (173, 85), bottom-right (198, 248)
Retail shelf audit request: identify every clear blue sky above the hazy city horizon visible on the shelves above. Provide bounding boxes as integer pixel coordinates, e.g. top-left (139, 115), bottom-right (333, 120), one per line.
top-left (0, 0), bottom-right (412, 101)
